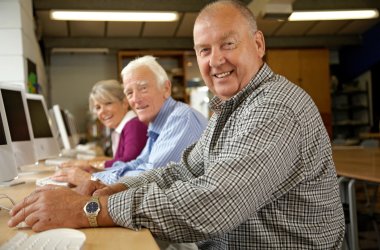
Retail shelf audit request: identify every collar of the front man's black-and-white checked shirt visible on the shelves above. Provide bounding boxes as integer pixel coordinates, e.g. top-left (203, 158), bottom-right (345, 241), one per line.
top-left (209, 63), bottom-right (274, 113)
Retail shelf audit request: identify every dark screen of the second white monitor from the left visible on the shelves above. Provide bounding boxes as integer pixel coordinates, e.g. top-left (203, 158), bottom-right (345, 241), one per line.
top-left (1, 89), bottom-right (30, 141)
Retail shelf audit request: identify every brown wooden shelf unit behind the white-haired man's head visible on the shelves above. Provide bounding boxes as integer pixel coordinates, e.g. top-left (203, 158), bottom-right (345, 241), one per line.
top-left (118, 50), bottom-right (192, 103)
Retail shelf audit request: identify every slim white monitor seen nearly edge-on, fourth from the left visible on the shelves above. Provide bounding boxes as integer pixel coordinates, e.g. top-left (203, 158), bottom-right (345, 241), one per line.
top-left (52, 104), bottom-right (75, 150)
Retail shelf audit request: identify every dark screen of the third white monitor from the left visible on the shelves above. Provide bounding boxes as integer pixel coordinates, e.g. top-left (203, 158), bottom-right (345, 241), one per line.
top-left (27, 99), bottom-right (53, 138)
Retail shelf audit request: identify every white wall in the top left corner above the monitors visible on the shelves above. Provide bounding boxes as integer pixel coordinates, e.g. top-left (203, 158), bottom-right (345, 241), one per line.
top-left (0, 0), bottom-right (47, 89)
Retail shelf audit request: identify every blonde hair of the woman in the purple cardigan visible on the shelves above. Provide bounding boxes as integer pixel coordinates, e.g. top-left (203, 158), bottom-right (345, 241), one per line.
top-left (88, 79), bottom-right (125, 112)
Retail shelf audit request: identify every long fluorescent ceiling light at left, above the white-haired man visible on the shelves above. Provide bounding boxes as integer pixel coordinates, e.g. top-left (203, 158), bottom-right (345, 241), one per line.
top-left (50, 10), bottom-right (178, 22)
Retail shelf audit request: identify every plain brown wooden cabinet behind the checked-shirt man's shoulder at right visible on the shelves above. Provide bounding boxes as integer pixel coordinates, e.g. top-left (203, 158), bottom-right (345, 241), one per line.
top-left (266, 49), bottom-right (332, 138)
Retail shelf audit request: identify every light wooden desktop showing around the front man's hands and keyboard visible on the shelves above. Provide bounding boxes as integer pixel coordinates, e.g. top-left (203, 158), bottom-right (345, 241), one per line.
top-left (0, 166), bottom-right (159, 250)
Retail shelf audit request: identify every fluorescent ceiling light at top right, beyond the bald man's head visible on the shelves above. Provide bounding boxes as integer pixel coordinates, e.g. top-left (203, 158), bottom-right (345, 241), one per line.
top-left (288, 9), bottom-right (379, 21)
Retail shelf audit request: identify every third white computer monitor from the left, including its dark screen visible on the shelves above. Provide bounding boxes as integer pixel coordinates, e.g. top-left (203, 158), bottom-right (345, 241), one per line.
top-left (26, 94), bottom-right (60, 160)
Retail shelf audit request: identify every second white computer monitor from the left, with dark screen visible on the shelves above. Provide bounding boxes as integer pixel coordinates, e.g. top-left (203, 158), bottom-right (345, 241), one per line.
top-left (0, 83), bottom-right (36, 167)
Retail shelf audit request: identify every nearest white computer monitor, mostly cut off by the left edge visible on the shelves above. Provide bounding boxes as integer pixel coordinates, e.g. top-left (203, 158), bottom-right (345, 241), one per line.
top-left (0, 98), bottom-right (18, 184)
